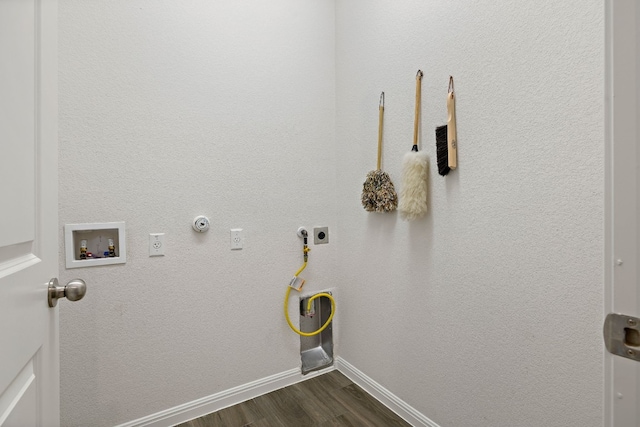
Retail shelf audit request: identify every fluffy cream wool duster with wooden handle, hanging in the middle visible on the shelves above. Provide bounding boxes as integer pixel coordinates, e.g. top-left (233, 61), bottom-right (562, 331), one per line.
top-left (398, 70), bottom-right (429, 220)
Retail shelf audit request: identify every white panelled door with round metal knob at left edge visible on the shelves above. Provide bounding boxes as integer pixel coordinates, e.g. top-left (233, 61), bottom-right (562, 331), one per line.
top-left (0, 0), bottom-right (60, 427)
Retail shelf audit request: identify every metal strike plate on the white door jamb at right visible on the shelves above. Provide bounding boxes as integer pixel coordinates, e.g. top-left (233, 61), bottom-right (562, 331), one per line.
top-left (603, 313), bottom-right (640, 362)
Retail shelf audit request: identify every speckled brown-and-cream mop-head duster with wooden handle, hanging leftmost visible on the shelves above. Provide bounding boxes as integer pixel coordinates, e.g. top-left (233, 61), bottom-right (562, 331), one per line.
top-left (361, 92), bottom-right (398, 212)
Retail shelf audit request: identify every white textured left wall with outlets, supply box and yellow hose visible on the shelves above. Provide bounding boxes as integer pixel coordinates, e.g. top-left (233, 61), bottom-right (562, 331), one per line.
top-left (60, 0), bottom-right (337, 427)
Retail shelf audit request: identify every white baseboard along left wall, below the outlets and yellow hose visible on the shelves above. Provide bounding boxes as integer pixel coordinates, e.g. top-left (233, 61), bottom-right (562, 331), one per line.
top-left (116, 365), bottom-right (335, 427)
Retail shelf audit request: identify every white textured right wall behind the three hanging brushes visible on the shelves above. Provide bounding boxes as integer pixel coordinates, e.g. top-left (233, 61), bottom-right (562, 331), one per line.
top-left (336, 0), bottom-right (604, 427)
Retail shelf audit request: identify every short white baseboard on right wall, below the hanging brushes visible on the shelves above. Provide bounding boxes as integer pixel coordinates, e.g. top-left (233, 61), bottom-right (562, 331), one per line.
top-left (335, 357), bottom-right (440, 427)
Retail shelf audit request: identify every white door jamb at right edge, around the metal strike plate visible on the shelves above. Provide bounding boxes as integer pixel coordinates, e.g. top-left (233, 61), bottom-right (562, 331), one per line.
top-left (605, 0), bottom-right (640, 427)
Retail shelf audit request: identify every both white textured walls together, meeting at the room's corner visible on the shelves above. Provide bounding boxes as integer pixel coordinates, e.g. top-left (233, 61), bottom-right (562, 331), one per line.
top-left (60, 0), bottom-right (604, 427)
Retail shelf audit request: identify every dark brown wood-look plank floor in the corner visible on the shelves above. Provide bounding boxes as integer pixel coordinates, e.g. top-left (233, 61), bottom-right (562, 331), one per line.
top-left (177, 371), bottom-right (410, 427)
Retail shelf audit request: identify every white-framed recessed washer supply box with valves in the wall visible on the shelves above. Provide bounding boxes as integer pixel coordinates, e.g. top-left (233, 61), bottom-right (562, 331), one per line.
top-left (64, 222), bottom-right (127, 268)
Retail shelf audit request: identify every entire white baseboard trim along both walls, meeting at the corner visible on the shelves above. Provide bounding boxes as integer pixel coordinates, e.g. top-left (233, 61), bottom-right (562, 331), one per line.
top-left (116, 357), bottom-right (440, 427)
